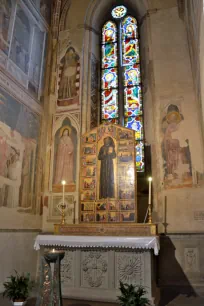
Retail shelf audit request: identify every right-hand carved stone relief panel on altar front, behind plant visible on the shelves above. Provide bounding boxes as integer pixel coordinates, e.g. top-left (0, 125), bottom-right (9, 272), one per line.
top-left (115, 252), bottom-right (144, 288)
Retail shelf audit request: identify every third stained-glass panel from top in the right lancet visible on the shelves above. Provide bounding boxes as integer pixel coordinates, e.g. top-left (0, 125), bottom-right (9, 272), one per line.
top-left (124, 64), bottom-right (141, 86)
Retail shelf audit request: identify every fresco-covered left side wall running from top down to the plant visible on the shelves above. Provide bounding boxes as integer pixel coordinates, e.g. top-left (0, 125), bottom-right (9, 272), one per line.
top-left (0, 0), bottom-right (52, 292)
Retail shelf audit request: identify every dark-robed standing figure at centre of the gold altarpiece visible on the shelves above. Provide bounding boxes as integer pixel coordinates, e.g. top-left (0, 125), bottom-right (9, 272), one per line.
top-left (98, 136), bottom-right (116, 199)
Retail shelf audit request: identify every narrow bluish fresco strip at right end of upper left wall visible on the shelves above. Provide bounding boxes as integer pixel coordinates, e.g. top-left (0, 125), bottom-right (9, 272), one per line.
top-left (28, 27), bottom-right (45, 95)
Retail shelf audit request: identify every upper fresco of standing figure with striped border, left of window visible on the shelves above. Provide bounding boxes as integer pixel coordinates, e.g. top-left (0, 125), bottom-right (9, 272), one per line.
top-left (57, 47), bottom-right (80, 106)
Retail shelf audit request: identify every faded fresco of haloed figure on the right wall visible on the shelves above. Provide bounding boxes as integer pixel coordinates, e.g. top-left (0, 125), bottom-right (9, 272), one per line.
top-left (162, 104), bottom-right (192, 189)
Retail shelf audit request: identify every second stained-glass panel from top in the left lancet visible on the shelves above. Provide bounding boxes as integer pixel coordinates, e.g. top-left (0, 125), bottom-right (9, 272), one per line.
top-left (102, 43), bottom-right (117, 68)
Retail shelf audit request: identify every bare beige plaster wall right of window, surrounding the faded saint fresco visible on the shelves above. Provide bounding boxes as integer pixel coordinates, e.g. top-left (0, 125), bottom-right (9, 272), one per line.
top-left (150, 6), bottom-right (203, 232)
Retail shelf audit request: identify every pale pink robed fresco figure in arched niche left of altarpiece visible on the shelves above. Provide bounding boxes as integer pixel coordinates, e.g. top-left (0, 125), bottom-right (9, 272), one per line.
top-left (54, 129), bottom-right (74, 185)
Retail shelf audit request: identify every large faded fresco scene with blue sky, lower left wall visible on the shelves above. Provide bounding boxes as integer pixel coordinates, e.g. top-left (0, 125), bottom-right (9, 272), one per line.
top-left (0, 85), bottom-right (40, 213)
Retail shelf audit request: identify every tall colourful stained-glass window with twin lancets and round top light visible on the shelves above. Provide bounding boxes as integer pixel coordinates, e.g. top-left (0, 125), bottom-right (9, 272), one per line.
top-left (101, 5), bottom-right (145, 172)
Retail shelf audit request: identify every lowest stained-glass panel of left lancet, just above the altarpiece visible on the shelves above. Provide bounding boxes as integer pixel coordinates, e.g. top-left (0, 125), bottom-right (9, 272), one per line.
top-left (101, 89), bottom-right (118, 119)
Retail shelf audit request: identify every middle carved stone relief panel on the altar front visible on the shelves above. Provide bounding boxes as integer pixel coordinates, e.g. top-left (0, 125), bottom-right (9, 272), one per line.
top-left (81, 251), bottom-right (108, 289)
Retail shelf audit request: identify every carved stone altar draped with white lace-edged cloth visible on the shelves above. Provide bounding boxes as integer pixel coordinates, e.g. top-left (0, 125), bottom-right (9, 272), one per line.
top-left (34, 233), bottom-right (159, 305)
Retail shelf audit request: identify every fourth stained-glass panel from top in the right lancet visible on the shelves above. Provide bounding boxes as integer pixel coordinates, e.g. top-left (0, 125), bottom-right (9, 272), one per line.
top-left (125, 86), bottom-right (142, 117)
